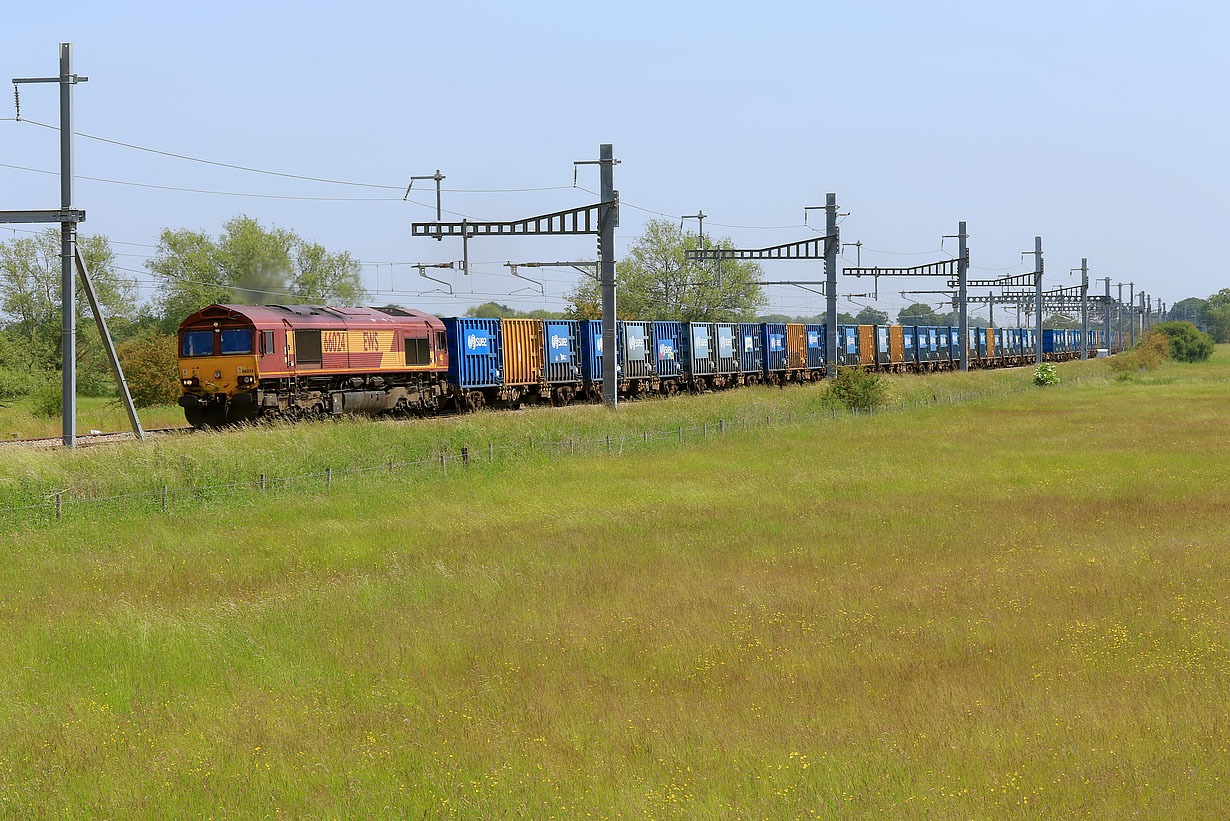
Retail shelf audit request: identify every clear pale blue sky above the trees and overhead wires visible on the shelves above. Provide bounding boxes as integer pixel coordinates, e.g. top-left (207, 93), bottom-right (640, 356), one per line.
top-left (0, 1), bottom-right (1230, 314)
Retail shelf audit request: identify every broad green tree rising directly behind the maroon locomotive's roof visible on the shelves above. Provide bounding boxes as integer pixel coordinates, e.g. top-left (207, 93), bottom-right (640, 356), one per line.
top-left (145, 215), bottom-right (364, 331)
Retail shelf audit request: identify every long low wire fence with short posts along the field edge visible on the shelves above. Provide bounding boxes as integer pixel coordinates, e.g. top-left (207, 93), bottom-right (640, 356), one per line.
top-left (0, 379), bottom-right (1062, 523)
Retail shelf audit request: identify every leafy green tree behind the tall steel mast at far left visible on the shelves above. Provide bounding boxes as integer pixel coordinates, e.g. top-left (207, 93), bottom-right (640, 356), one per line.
top-left (0, 228), bottom-right (140, 393)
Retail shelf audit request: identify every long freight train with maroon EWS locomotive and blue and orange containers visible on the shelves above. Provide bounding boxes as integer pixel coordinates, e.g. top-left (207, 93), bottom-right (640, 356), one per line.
top-left (178, 305), bottom-right (1124, 427)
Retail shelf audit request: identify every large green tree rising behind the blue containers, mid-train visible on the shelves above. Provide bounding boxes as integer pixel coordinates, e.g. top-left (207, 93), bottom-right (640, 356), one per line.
top-left (567, 219), bottom-right (766, 321)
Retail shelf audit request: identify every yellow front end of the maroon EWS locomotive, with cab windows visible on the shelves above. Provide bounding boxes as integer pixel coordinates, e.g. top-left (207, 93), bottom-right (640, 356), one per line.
top-left (178, 321), bottom-right (260, 427)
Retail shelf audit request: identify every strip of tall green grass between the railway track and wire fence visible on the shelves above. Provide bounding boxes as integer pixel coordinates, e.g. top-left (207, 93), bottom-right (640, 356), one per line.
top-left (0, 362), bottom-right (1141, 516)
